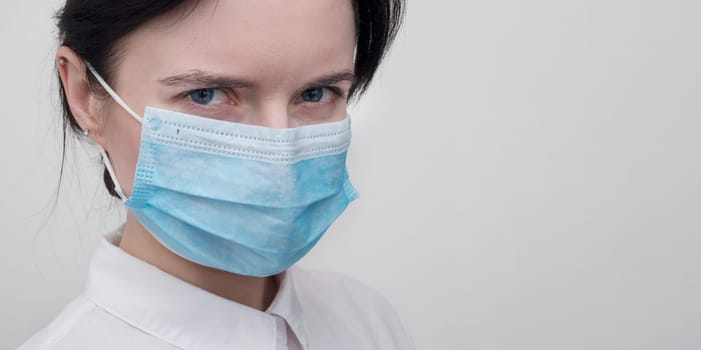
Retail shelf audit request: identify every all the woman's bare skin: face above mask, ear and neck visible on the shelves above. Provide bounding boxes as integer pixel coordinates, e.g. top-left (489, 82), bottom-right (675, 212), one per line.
top-left (56, 0), bottom-right (355, 310)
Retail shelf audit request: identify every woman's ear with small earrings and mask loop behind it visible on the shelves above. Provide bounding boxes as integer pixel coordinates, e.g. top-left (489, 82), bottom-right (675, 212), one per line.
top-left (56, 46), bottom-right (105, 147)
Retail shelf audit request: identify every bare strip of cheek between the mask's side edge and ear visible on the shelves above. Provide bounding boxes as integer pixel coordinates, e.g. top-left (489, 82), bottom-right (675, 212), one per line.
top-left (104, 107), bottom-right (141, 197)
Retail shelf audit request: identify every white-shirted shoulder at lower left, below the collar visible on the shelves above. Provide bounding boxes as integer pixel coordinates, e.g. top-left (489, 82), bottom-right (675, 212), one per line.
top-left (18, 296), bottom-right (175, 350)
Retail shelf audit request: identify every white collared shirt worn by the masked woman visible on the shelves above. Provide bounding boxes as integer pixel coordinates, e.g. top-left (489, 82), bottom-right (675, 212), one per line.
top-left (19, 232), bottom-right (413, 350)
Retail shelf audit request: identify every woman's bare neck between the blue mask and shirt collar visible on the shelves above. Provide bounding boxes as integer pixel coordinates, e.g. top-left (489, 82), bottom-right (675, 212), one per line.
top-left (119, 214), bottom-right (278, 310)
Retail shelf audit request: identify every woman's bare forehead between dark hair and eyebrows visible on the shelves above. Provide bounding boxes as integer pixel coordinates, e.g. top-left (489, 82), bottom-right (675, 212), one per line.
top-left (119, 0), bottom-right (355, 85)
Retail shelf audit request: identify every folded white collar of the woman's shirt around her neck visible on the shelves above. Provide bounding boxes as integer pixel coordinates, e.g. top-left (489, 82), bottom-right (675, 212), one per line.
top-left (85, 231), bottom-right (307, 349)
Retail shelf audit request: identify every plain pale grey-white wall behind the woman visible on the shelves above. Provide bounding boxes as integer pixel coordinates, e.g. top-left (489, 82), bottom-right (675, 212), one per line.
top-left (0, 0), bottom-right (701, 350)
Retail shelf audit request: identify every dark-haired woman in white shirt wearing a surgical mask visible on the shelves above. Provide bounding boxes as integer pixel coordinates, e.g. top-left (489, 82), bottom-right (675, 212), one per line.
top-left (21, 0), bottom-right (411, 349)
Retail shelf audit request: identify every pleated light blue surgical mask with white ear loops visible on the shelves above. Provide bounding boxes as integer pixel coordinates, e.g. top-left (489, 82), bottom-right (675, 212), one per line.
top-left (88, 65), bottom-right (357, 277)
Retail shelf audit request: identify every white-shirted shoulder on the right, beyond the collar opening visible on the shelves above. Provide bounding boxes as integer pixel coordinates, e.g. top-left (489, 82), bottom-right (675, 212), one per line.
top-left (294, 268), bottom-right (413, 349)
